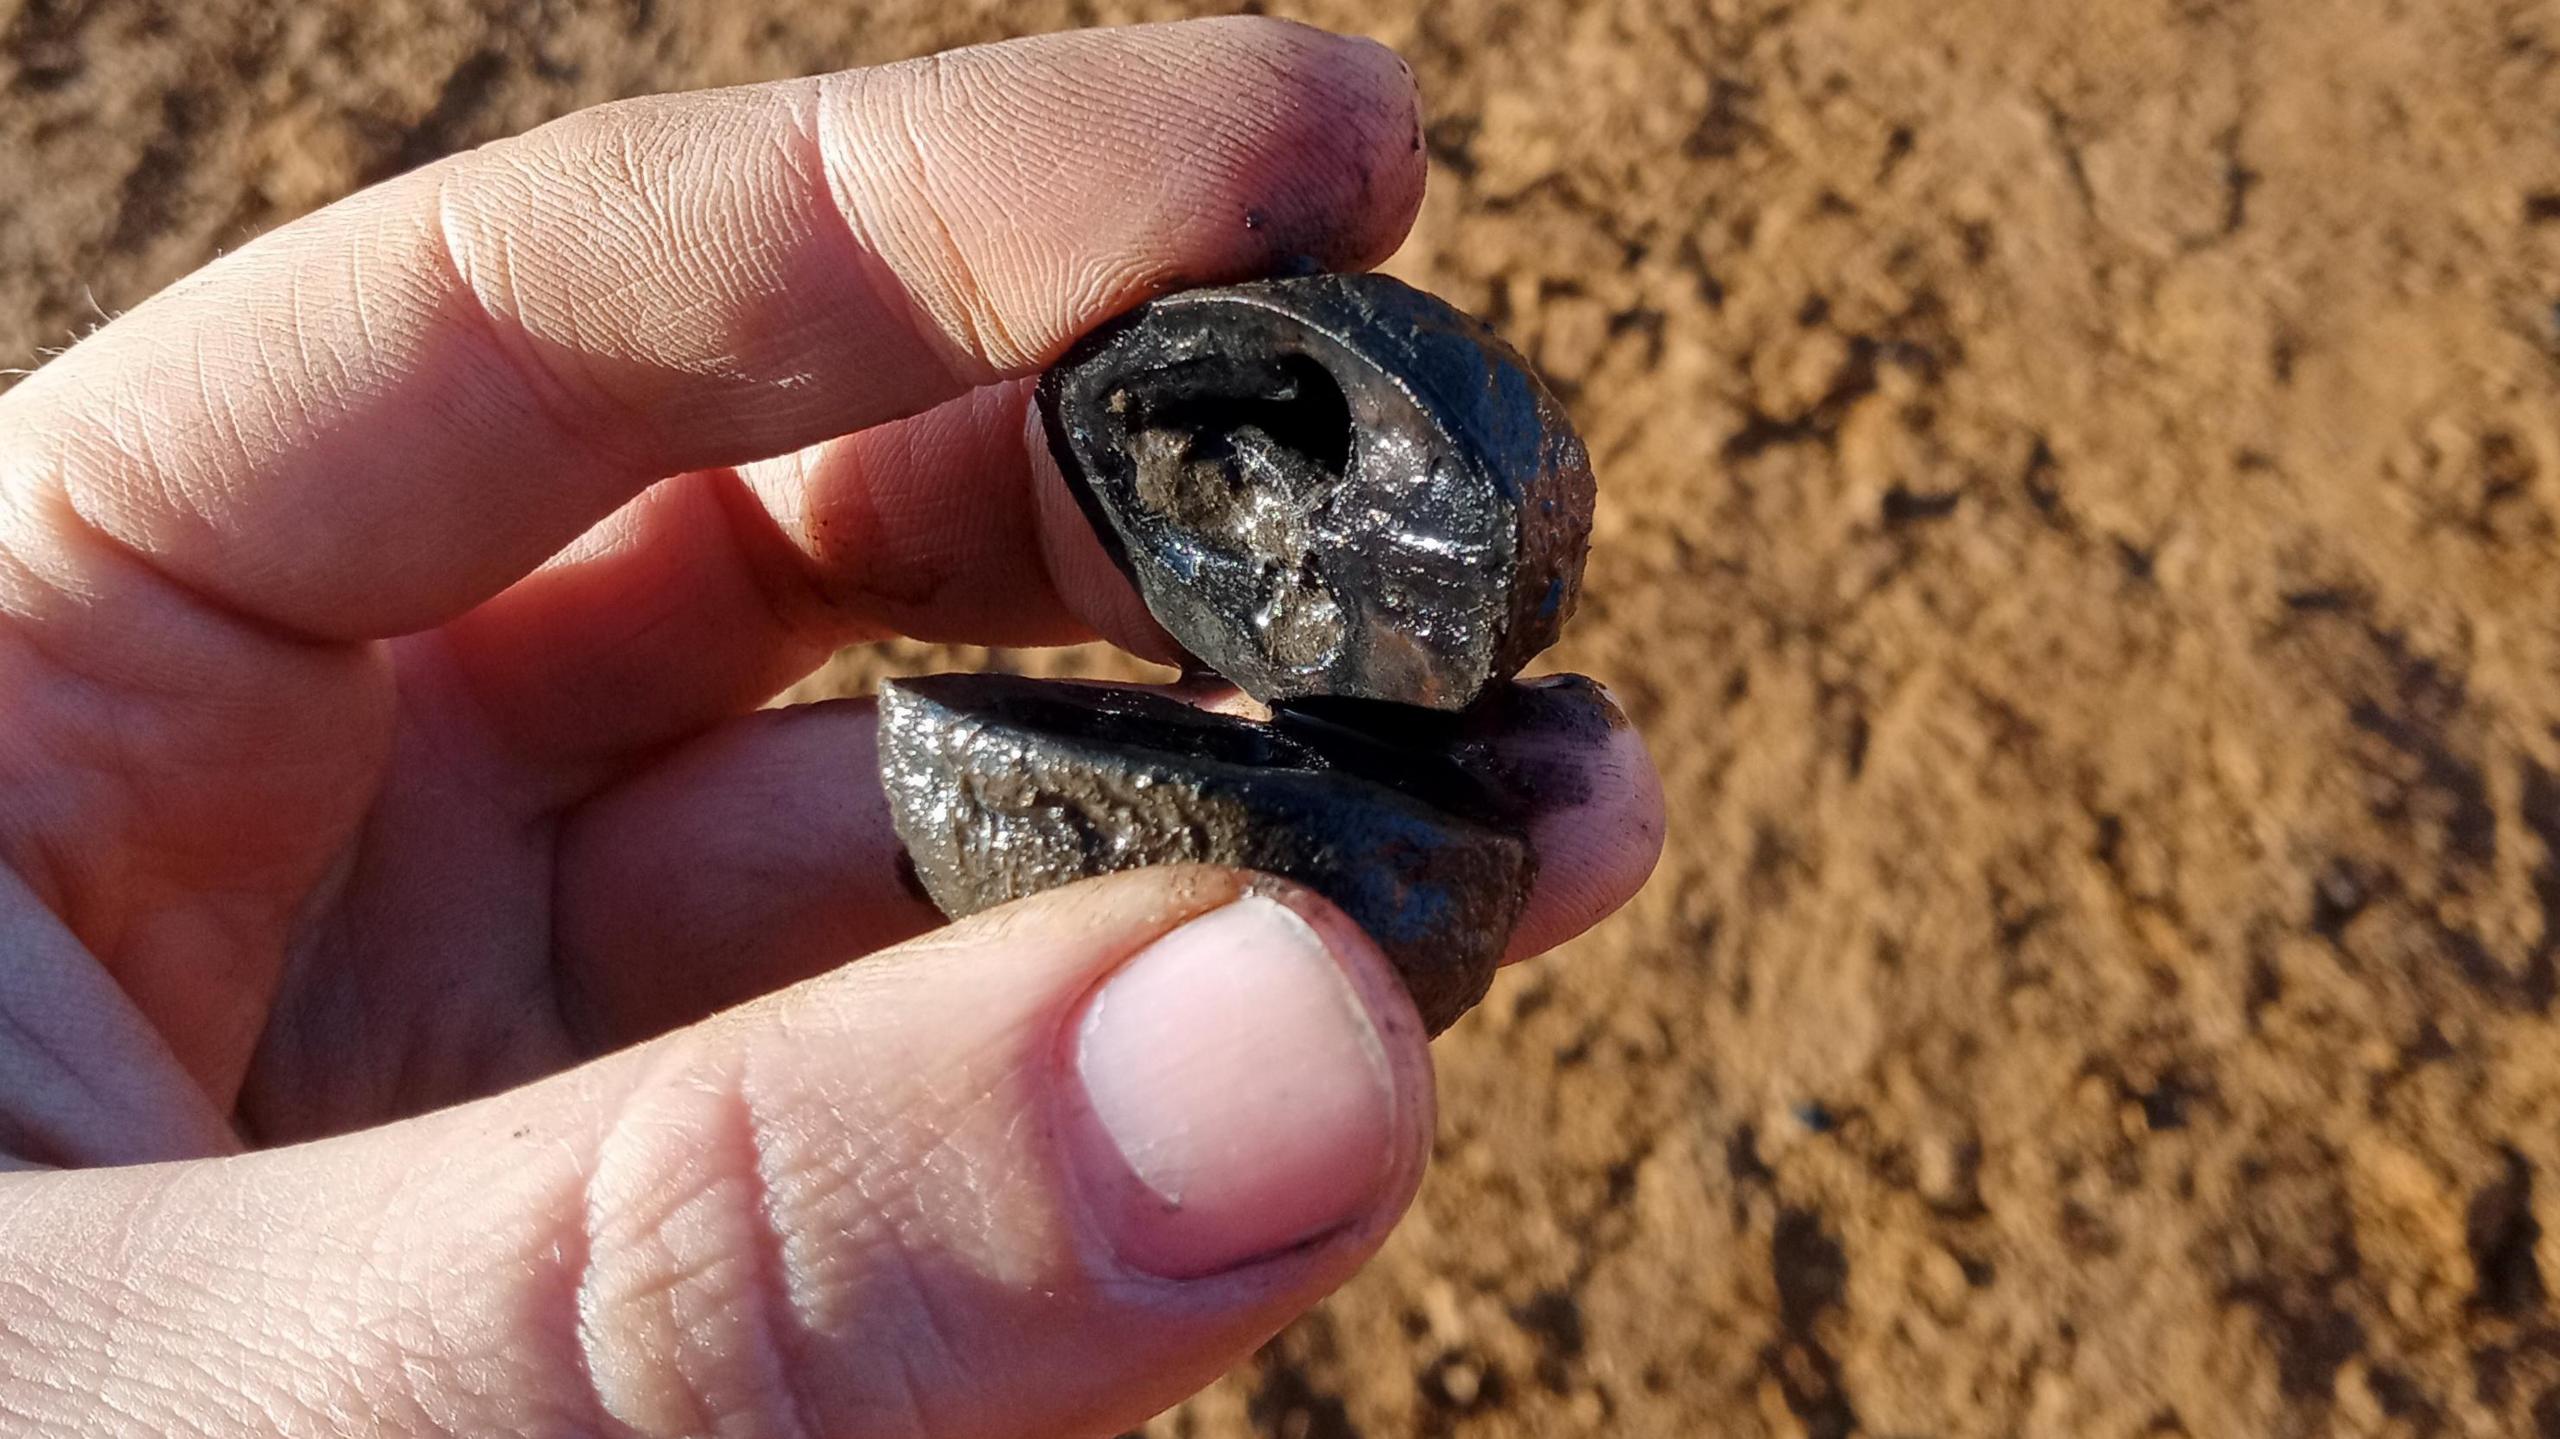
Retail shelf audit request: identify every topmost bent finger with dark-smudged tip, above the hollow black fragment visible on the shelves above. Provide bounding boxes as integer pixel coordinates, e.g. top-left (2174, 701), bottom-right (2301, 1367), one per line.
top-left (0, 20), bottom-right (1423, 640)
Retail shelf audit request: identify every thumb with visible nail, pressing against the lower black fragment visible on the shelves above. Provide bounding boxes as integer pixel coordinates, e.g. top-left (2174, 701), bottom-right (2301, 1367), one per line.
top-left (0, 871), bottom-right (1431, 1439)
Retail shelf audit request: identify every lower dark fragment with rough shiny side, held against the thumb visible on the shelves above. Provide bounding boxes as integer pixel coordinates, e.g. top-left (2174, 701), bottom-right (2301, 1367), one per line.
top-left (881, 673), bottom-right (1531, 1034)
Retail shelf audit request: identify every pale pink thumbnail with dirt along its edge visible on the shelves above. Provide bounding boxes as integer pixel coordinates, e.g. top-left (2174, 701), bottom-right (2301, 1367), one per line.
top-left (1075, 894), bottom-right (1398, 1278)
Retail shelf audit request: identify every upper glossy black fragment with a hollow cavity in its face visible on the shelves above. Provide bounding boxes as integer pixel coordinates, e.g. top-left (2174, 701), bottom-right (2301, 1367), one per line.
top-left (1039, 274), bottom-right (1592, 712)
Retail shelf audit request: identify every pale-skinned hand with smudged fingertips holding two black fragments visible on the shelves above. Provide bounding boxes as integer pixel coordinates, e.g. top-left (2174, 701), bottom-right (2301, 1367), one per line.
top-left (0, 20), bottom-right (1661, 1439)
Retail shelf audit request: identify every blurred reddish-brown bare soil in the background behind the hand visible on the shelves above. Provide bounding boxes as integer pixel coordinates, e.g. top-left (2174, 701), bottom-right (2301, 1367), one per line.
top-left (0, 0), bottom-right (2560, 1439)
